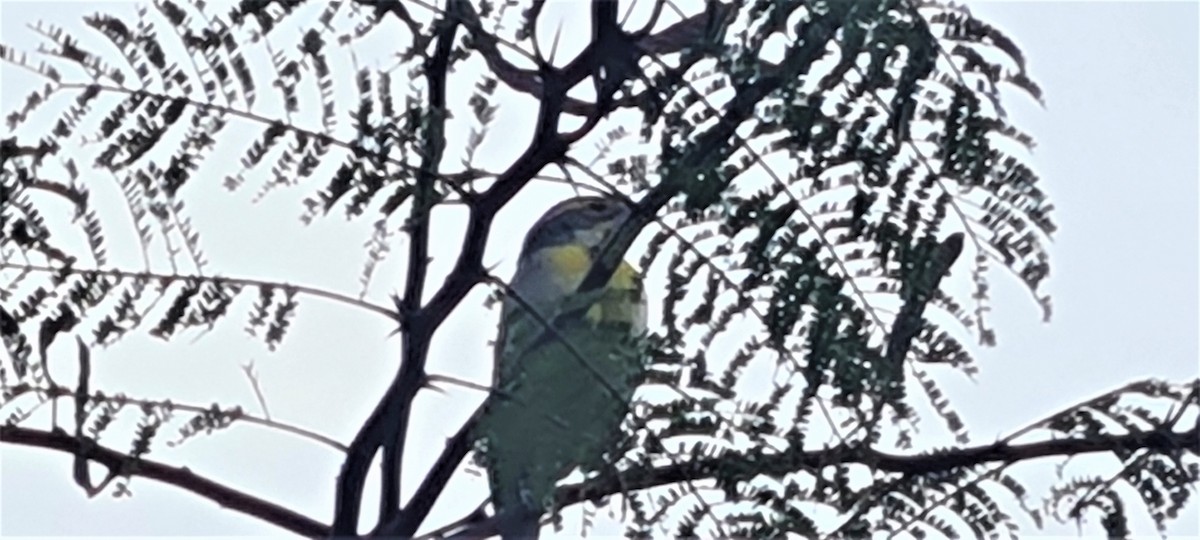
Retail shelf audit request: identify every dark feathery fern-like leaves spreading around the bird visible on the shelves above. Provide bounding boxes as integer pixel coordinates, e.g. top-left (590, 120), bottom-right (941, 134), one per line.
top-left (0, 0), bottom-right (1200, 538)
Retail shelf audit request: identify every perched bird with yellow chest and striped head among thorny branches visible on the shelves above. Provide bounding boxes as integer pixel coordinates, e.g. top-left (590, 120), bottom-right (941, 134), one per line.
top-left (476, 197), bottom-right (646, 540)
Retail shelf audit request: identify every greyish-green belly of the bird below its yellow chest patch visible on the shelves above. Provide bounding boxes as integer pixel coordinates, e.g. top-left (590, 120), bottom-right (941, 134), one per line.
top-left (481, 320), bottom-right (643, 508)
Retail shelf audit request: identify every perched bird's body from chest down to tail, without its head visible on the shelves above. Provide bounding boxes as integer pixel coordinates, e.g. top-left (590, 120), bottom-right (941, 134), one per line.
top-left (478, 265), bottom-right (646, 539)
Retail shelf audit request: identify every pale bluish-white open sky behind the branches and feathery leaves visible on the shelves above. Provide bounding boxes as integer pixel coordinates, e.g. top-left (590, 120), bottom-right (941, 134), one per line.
top-left (0, 0), bottom-right (1200, 536)
